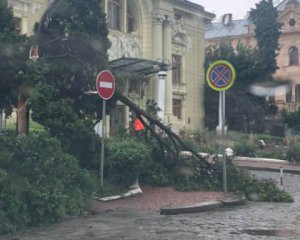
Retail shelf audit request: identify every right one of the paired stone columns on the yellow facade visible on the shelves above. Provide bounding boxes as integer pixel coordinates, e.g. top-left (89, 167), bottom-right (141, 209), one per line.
top-left (163, 17), bottom-right (173, 122)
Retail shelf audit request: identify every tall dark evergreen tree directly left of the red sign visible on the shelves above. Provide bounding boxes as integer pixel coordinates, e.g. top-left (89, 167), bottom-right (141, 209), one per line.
top-left (30, 0), bottom-right (115, 167)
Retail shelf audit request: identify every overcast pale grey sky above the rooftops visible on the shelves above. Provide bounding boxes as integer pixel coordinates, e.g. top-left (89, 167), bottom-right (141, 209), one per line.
top-left (190, 0), bottom-right (259, 20)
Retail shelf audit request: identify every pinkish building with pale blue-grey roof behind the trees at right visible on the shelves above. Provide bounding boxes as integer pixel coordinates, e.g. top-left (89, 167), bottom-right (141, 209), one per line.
top-left (205, 0), bottom-right (300, 112)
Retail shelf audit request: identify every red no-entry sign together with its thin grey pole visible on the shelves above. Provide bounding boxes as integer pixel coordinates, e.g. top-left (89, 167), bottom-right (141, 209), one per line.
top-left (96, 70), bottom-right (115, 188)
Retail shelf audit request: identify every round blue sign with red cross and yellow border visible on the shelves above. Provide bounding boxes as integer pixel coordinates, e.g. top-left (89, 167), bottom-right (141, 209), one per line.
top-left (206, 60), bottom-right (236, 91)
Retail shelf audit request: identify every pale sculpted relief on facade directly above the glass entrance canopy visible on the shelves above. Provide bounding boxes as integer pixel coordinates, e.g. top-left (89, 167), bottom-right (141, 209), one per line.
top-left (108, 31), bottom-right (141, 60)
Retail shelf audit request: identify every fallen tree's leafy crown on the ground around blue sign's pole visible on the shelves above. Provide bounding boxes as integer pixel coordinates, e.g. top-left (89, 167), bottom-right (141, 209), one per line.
top-left (176, 158), bottom-right (293, 202)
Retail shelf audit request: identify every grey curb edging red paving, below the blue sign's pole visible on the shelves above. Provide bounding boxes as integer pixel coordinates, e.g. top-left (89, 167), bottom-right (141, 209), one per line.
top-left (160, 196), bottom-right (247, 215)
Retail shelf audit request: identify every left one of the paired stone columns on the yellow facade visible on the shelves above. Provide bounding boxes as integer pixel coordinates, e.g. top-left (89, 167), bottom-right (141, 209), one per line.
top-left (152, 13), bottom-right (163, 102)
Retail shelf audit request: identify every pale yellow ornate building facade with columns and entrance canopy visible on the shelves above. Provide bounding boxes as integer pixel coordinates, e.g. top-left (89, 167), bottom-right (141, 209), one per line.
top-left (105, 0), bottom-right (214, 131)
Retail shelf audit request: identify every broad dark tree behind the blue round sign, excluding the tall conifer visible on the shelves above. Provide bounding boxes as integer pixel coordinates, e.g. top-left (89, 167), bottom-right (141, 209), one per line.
top-left (204, 42), bottom-right (267, 132)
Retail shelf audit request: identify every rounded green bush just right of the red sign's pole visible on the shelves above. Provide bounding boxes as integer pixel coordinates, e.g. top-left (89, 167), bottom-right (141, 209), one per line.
top-left (107, 137), bottom-right (150, 187)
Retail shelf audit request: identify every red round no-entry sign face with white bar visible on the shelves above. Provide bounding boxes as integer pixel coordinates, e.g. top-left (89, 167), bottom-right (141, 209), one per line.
top-left (96, 70), bottom-right (115, 100)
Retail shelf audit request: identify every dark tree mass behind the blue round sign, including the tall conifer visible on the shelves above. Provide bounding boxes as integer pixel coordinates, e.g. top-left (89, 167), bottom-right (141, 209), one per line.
top-left (205, 0), bottom-right (281, 132)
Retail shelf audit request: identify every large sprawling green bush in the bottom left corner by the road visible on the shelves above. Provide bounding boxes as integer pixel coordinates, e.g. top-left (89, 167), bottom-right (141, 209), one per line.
top-left (0, 133), bottom-right (95, 234)
